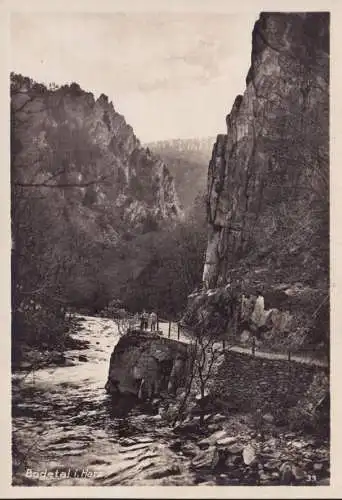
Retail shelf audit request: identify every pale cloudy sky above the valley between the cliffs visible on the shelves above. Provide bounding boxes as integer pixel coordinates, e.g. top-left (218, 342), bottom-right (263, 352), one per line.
top-left (11, 12), bottom-right (259, 142)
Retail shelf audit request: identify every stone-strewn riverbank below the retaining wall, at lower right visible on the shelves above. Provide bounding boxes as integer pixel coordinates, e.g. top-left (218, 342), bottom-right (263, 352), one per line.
top-left (167, 413), bottom-right (330, 485)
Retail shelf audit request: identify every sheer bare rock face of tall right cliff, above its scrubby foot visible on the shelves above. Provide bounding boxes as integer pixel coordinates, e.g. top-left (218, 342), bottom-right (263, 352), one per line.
top-left (203, 13), bottom-right (329, 288)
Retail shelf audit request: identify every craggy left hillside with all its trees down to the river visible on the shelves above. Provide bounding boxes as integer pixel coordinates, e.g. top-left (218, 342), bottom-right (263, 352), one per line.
top-left (11, 74), bottom-right (205, 360)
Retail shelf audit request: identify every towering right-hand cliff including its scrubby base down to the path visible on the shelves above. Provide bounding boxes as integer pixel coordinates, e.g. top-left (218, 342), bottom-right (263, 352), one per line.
top-left (186, 12), bottom-right (329, 352)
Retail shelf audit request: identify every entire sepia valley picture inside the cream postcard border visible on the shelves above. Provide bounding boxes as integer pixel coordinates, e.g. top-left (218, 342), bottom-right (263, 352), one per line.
top-left (8, 2), bottom-right (332, 492)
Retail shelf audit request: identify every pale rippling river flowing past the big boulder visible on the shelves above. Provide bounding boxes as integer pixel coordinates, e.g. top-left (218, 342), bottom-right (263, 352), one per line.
top-left (13, 317), bottom-right (195, 486)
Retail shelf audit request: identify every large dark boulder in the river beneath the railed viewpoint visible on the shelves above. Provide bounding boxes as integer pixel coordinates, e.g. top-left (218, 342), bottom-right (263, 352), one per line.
top-left (106, 331), bottom-right (188, 399)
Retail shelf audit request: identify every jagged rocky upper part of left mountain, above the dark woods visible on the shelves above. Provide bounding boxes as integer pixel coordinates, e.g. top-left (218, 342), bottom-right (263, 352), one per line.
top-left (11, 74), bottom-right (181, 240)
